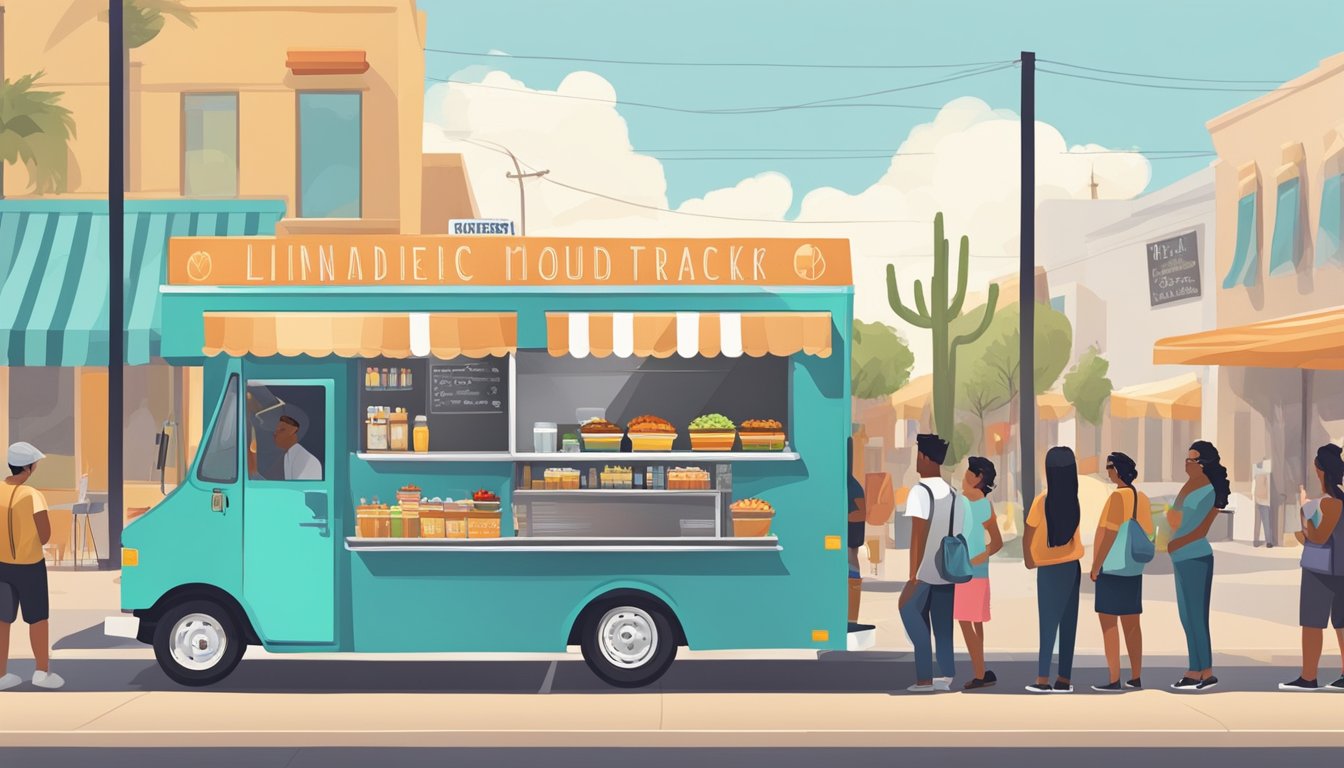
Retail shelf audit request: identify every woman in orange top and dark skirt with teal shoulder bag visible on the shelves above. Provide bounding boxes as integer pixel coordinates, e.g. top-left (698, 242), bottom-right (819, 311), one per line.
top-left (1091, 452), bottom-right (1153, 693)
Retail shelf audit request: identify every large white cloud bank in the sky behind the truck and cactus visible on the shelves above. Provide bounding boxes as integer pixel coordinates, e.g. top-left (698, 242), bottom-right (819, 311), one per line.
top-left (425, 71), bottom-right (1150, 370)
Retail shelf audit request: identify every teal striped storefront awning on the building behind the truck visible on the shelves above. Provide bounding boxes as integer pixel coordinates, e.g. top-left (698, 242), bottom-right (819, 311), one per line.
top-left (0, 199), bottom-right (285, 366)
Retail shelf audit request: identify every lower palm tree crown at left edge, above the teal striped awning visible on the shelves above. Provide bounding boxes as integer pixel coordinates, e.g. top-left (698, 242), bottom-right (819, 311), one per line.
top-left (0, 73), bottom-right (75, 196)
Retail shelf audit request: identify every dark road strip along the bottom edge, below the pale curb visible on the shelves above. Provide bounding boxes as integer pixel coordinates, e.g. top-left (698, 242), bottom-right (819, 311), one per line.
top-left (0, 746), bottom-right (1339, 768)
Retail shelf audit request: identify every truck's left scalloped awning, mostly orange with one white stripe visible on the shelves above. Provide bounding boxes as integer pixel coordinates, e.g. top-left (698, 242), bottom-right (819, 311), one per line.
top-left (202, 312), bottom-right (517, 359)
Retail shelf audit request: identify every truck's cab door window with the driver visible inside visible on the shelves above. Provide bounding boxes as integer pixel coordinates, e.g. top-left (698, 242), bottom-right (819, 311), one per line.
top-left (247, 382), bottom-right (327, 480)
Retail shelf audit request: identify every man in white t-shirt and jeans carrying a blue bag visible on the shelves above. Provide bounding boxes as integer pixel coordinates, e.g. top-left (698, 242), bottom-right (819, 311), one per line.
top-left (900, 434), bottom-right (964, 693)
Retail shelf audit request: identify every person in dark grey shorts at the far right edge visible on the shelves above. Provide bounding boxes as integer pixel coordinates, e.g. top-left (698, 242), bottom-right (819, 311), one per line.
top-left (1278, 444), bottom-right (1344, 693)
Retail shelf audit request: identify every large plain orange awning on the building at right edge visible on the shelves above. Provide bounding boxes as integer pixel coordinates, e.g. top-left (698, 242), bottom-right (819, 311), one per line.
top-left (1153, 307), bottom-right (1344, 371)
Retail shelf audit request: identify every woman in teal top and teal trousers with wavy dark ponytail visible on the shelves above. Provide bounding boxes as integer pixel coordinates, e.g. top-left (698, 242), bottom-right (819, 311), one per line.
top-left (1167, 440), bottom-right (1231, 691)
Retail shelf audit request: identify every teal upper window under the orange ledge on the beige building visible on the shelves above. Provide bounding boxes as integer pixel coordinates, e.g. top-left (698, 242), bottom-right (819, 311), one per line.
top-left (298, 93), bottom-right (363, 219)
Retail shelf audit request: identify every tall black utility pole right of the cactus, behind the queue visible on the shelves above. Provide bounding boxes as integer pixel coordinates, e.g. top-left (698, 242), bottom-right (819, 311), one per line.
top-left (1017, 51), bottom-right (1036, 507)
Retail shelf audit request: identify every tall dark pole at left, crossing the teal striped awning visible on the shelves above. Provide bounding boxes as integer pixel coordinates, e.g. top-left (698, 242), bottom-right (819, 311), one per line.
top-left (108, 0), bottom-right (126, 568)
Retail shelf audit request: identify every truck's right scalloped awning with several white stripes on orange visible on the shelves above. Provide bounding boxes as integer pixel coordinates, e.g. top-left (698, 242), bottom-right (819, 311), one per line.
top-left (546, 312), bottom-right (832, 358)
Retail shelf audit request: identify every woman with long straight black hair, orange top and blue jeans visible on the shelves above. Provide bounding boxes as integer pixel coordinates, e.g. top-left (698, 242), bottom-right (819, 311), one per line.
top-left (1023, 445), bottom-right (1083, 693)
